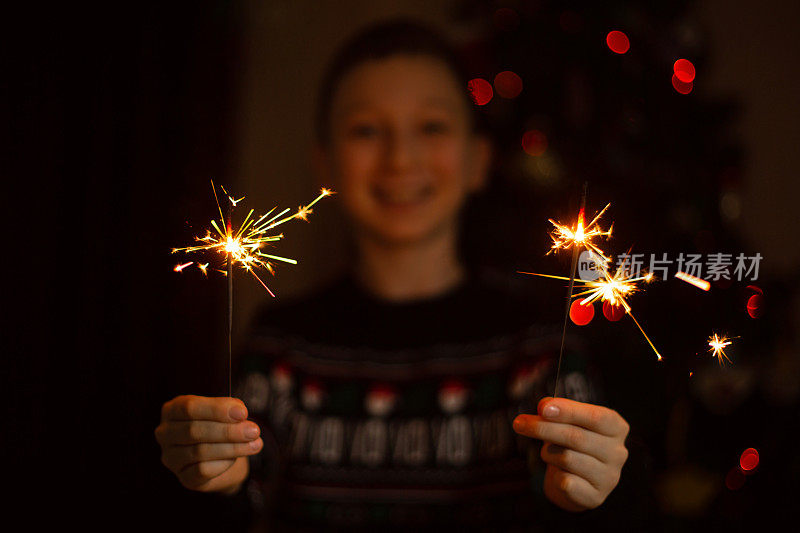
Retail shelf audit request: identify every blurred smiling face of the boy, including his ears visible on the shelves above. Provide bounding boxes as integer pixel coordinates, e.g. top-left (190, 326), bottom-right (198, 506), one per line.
top-left (322, 55), bottom-right (489, 245)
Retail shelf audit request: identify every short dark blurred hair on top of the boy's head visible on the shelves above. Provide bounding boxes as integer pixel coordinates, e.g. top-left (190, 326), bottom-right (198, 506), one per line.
top-left (315, 19), bottom-right (484, 144)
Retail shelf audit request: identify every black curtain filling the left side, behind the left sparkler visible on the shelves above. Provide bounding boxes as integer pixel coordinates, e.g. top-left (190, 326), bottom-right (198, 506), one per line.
top-left (7, 1), bottom-right (244, 530)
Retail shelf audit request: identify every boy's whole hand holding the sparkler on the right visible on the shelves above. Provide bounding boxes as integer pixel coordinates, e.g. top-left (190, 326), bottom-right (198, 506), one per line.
top-left (514, 397), bottom-right (630, 511)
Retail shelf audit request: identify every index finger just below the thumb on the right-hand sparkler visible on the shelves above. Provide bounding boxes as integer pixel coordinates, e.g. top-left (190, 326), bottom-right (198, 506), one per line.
top-left (514, 415), bottom-right (617, 463)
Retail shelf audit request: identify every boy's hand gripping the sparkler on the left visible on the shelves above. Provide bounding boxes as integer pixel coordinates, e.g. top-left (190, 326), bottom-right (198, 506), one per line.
top-left (155, 396), bottom-right (264, 493)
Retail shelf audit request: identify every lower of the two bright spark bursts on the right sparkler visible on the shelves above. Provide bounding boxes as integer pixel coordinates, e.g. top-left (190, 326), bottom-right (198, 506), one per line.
top-left (519, 262), bottom-right (663, 361)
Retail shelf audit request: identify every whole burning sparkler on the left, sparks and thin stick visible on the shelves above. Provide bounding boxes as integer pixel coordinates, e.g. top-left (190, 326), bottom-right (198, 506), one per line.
top-left (172, 181), bottom-right (335, 395)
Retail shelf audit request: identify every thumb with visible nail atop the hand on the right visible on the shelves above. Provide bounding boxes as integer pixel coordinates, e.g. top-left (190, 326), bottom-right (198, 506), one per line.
top-left (538, 397), bottom-right (629, 437)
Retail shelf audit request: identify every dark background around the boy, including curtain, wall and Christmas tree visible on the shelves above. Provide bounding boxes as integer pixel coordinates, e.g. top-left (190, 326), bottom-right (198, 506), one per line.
top-left (7, 0), bottom-right (800, 531)
